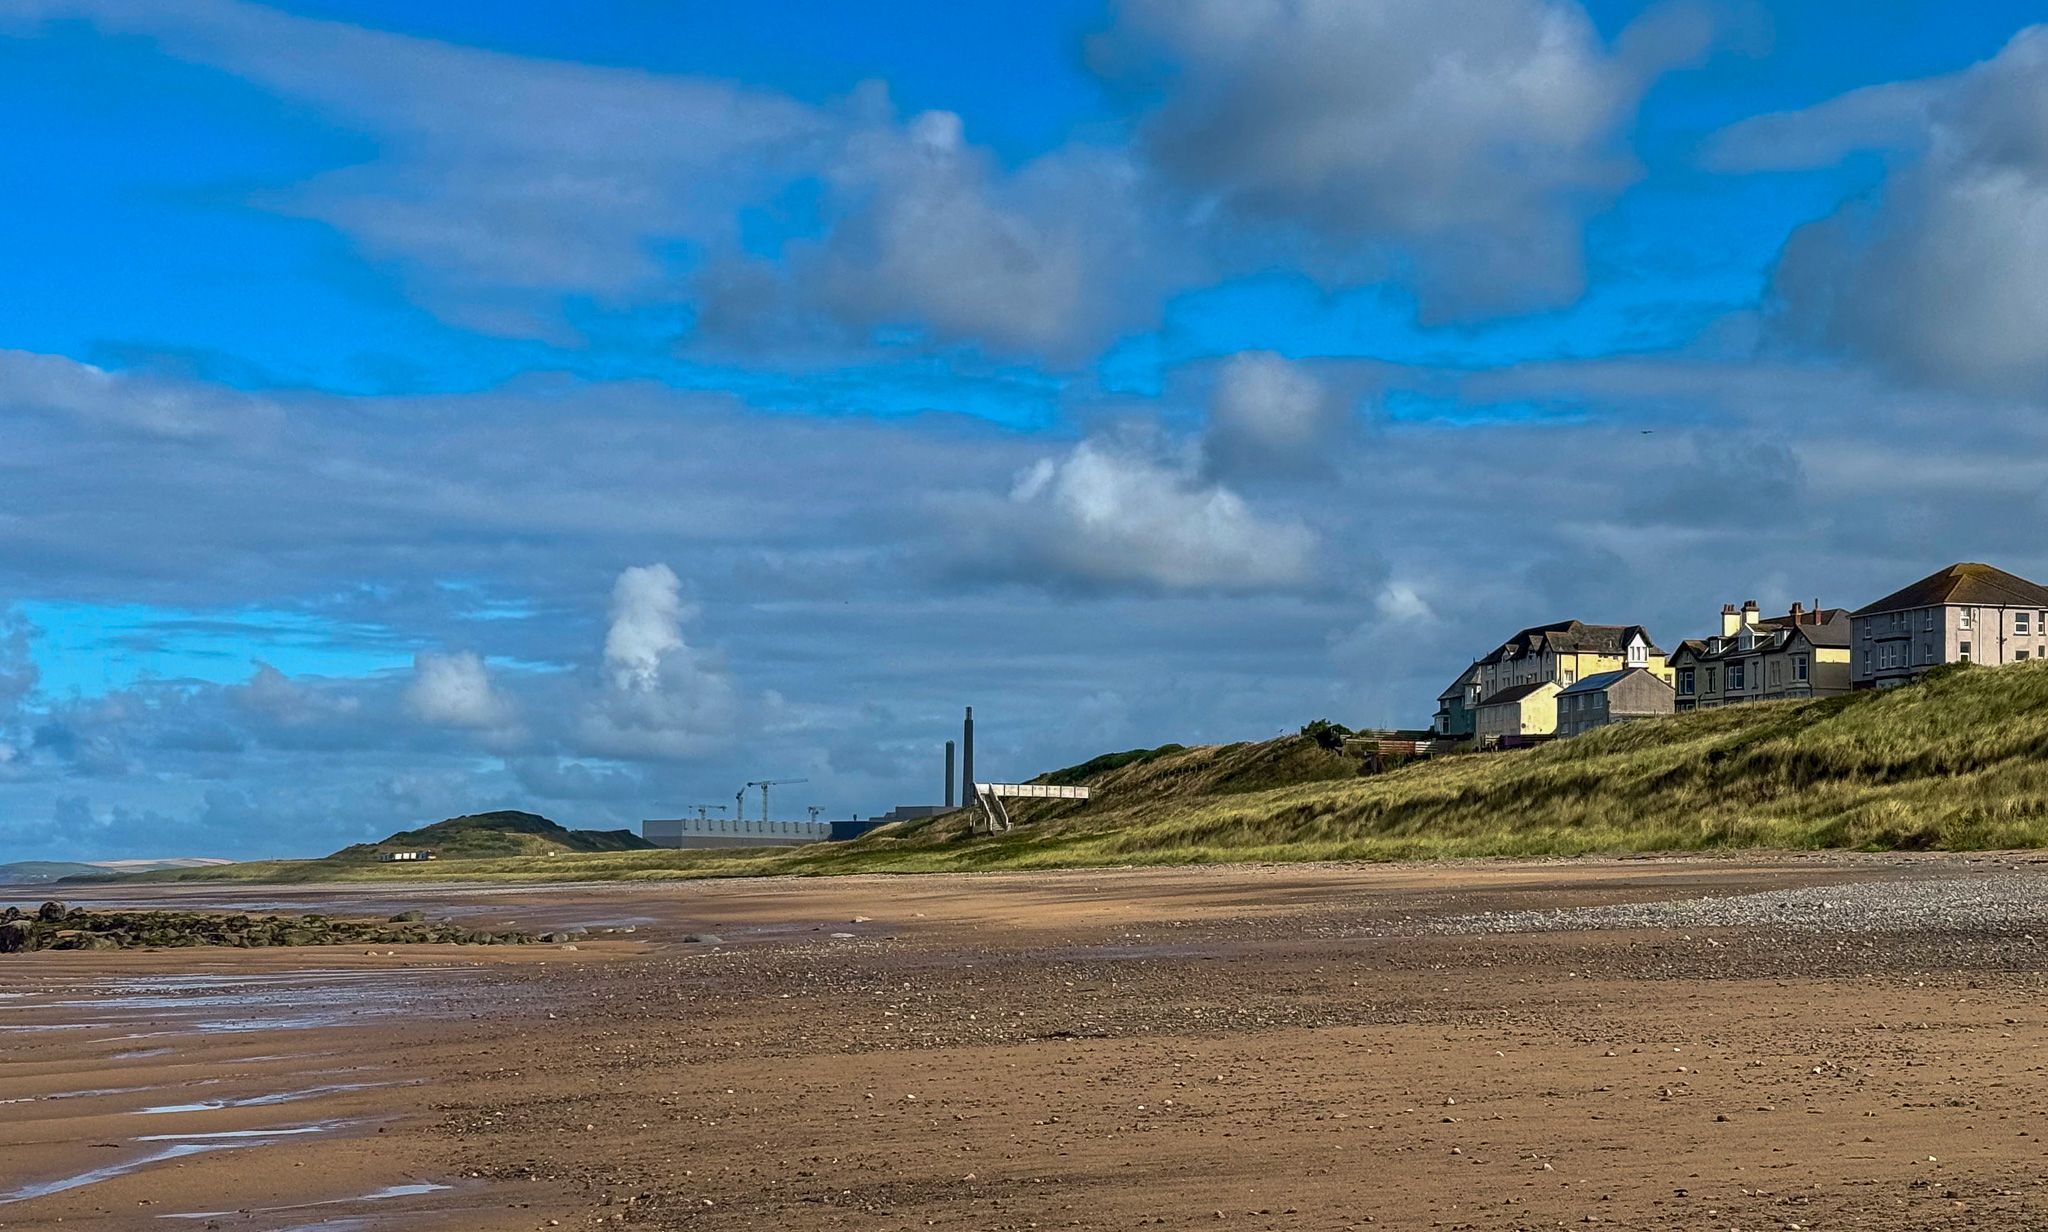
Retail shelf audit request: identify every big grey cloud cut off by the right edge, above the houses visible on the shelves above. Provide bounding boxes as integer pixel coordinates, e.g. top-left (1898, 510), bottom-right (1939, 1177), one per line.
top-left (1722, 27), bottom-right (2048, 397)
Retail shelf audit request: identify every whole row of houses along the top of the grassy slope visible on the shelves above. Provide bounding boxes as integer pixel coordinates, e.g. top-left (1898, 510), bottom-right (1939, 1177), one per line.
top-left (1436, 565), bottom-right (2048, 747)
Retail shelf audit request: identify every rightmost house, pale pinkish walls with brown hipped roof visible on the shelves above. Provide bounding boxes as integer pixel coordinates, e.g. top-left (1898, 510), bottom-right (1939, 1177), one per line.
top-left (1849, 563), bottom-right (2048, 690)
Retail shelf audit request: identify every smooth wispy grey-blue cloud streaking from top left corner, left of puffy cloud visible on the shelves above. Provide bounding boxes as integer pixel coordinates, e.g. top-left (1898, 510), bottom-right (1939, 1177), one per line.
top-left (16, 0), bottom-right (827, 332)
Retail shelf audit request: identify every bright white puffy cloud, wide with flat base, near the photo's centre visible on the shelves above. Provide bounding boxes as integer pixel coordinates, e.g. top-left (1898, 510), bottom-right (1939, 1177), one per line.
top-left (1001, 440), bottom-right (1315, 589)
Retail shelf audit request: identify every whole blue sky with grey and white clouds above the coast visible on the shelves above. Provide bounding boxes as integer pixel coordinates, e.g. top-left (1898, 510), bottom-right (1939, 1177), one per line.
top-left (0, 0), bottom-right (2048, 860)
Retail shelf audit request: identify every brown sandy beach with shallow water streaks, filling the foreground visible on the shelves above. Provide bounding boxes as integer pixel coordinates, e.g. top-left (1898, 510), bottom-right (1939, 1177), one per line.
top-left (0, 857), bottom-right (2048, 1232)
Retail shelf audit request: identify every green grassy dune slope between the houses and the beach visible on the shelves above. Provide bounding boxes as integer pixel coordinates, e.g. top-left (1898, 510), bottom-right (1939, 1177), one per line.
top-left (119, 663), bottom-right (2048, 880)
